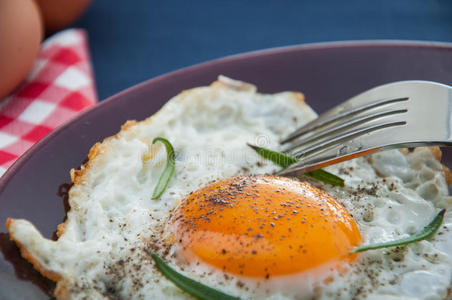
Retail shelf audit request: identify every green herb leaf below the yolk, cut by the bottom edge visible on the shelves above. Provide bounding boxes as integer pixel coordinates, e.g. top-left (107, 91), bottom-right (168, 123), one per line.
top-left (151, 253), bottom-right (240, 300)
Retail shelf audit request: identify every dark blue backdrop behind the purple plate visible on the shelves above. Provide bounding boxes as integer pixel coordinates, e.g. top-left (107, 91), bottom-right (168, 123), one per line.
top-left (74, 0), bottom-right (452, 99)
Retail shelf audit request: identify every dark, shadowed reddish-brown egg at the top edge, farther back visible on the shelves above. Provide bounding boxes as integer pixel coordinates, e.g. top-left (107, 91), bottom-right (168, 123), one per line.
top-left (35, 0), bottom-right (91, 32)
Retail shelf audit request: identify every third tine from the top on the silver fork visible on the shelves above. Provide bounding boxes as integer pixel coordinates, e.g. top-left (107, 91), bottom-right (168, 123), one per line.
top-left (292, 121), bottom-right (406, 158)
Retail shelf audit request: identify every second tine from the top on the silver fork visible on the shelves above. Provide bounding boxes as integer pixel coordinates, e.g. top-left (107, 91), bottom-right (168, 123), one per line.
top-left (284, 109), bottom-right (408, 153)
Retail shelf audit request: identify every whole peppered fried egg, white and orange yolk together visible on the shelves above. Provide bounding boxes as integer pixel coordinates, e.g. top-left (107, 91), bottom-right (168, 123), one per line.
top-left (7, 77), bottom-right (452, 299)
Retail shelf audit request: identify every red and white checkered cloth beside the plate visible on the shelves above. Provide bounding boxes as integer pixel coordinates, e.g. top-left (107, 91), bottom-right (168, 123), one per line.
top-left (0, 29), bottom-right (97, 175)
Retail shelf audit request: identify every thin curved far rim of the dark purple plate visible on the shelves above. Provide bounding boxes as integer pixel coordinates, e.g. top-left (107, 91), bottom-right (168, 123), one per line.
top-left (0, 39), bottom-right (452, 190)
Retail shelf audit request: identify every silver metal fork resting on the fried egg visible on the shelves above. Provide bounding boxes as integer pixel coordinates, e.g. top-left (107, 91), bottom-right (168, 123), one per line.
top-left (279, 81), bottom-right (452, 175)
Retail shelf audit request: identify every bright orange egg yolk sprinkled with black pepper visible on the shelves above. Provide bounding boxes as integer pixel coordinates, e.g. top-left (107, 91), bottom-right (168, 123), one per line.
top-left (172, 176), bottom-right (361, 278)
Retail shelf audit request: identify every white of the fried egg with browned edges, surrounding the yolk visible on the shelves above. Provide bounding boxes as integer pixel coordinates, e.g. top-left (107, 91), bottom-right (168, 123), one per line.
top-left (8, 78), bottom-right (452, 299)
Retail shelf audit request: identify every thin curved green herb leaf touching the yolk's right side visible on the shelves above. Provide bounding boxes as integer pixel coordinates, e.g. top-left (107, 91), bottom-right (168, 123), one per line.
top-left (350, 208), bottom-right (446, 254)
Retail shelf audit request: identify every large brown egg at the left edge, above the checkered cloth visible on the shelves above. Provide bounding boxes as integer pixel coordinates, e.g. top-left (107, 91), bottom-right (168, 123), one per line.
top-left (0, 0), bottom-right (43, 99)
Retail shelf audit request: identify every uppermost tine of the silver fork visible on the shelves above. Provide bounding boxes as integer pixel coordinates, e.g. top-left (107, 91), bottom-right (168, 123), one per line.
top-left (280, 97), bottom-right (409, 144)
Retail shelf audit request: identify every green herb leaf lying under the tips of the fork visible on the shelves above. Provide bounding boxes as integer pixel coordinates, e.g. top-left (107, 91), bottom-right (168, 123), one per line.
top-left (248, 144), bottom-right (344, 186)
